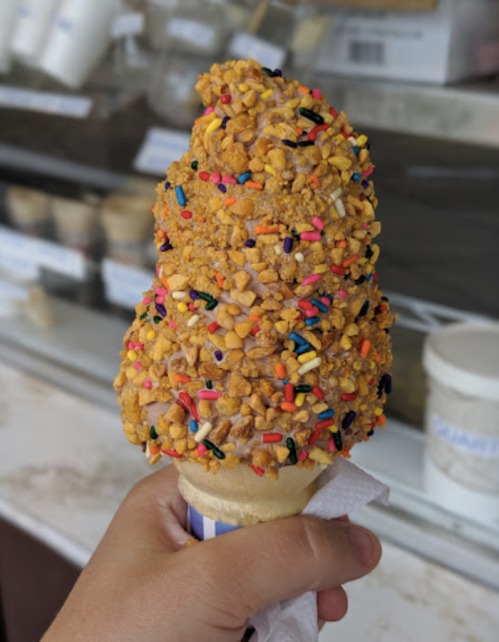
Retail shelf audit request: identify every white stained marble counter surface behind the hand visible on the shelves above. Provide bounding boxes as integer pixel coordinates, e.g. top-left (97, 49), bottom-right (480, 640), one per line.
top-left (0, 366), bottom-right (499, 642)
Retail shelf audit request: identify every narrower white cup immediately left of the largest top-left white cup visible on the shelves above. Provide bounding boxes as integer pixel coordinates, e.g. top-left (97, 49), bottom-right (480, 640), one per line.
top-left (10, 0), bottom-right (59, 64)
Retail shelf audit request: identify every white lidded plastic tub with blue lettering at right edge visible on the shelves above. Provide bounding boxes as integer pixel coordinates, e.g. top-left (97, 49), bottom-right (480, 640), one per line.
top-left (423, 323), bottom-right (499, 522)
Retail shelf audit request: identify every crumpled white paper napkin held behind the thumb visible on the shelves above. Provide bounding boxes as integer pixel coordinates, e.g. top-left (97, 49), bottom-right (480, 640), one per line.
top-left (251, 458), bottom-right (390, 642)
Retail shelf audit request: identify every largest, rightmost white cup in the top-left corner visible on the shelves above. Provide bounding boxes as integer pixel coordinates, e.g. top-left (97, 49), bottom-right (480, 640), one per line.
top-left (40, 0), bottom-right (118, 89)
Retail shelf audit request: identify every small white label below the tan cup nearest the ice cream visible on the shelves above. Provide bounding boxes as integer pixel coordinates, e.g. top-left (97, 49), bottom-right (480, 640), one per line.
top-left (102, 259), bottom-right (154, 310)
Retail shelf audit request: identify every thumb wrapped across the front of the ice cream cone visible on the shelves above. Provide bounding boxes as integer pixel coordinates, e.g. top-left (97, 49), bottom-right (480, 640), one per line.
top-left (179, 516), bottom-right (381, 617)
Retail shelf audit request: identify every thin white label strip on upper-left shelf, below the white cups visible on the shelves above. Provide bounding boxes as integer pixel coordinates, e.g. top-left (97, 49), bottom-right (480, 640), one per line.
top-left (0, 85), bottom-right (92, 118)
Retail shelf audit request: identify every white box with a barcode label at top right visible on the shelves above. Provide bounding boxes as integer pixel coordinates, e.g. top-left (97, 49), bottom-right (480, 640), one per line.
top-left (316, 0), bottom-right (499, 84)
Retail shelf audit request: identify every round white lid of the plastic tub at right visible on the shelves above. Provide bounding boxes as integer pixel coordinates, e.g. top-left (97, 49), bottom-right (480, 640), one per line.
top-left (423, 323), bottom-right (499, 401)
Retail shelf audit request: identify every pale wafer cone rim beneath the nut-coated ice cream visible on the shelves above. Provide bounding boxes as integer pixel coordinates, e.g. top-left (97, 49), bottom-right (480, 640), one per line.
top-left (174, 461), bottom-right (323, 526)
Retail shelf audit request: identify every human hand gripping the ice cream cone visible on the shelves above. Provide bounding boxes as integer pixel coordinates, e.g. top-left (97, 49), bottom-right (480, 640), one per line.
top-left (42, 466), bottom-right (381, 642)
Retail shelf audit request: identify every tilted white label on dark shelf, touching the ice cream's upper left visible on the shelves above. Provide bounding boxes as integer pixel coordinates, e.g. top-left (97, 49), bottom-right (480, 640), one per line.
top-left (133, 127), bottom-right (190, 176)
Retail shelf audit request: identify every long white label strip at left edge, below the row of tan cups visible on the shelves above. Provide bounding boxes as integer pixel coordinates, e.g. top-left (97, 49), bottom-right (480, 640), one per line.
top-left (0, 227), bottom-right (86, 281)
